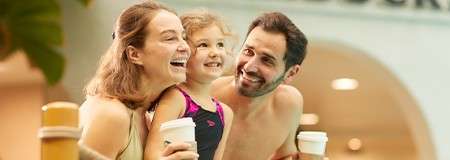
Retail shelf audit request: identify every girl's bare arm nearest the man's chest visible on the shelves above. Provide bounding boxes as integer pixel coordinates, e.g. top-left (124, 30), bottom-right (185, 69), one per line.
top-left (214, 103), bottom-right (233, 160)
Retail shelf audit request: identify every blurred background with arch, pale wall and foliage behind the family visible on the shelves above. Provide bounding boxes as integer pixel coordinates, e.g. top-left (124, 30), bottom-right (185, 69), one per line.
top-left (0, 0), bottom-right (450, 160)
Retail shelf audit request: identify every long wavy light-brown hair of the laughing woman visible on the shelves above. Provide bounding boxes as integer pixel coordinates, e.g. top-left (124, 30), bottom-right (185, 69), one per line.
top-left (85, 1), bottom-right (175, 109)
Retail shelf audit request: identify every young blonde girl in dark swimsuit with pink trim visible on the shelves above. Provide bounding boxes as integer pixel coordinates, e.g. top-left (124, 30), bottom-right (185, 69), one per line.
top-left (145, 10), bottom-right (233, 160)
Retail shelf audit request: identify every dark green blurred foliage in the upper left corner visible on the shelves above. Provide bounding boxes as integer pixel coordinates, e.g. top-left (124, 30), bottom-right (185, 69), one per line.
top-left (0, 0), bottom-right (91, 84)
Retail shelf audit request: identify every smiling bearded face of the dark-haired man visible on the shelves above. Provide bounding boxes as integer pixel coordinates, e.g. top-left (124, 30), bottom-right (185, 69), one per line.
top-left (235, 27), bottom-right (286, 97)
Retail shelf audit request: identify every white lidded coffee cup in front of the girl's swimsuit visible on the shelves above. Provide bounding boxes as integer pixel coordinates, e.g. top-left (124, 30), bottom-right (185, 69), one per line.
top-left (159, 117), bottom-right (195, 143)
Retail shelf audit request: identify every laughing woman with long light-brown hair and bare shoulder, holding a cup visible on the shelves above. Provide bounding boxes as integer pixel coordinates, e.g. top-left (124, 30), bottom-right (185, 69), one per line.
top-left (79, 1), bottom-right (198, 160)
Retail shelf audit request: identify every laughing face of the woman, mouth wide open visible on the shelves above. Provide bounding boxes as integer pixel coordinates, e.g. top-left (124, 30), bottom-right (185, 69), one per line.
top-left (142, 10), bottom-right (190, 85)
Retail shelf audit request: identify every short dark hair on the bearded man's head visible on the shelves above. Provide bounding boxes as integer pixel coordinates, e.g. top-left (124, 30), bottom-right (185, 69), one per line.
top-left (247, 12), bottom-right (308, 70)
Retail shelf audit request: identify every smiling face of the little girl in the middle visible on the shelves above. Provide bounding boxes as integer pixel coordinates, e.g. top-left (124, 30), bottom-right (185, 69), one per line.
top-left (187, 24), bottom-right (226, 83)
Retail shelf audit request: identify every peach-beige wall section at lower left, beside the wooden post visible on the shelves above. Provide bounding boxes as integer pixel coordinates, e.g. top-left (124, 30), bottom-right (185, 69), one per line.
top-left (0, 84), bottom-right (45, 160)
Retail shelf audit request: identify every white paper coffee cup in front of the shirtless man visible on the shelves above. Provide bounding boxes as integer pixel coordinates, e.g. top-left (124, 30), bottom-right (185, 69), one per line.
top-left (297, 131), bottom-right (328, 155)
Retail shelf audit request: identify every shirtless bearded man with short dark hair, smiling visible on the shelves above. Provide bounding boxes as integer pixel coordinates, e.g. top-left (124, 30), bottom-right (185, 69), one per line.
top-left (213, 12), bottom-right (307, 160)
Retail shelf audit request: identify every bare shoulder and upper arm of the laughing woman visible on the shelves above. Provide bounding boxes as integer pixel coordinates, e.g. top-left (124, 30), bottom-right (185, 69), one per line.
top-left (79, 97), bottom-right (130, 159)
